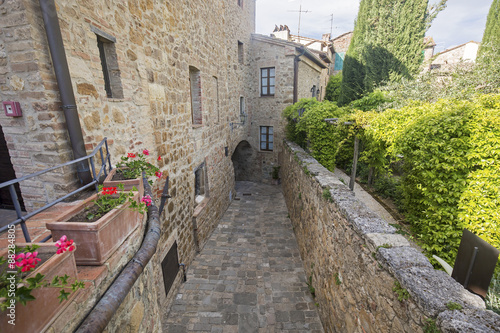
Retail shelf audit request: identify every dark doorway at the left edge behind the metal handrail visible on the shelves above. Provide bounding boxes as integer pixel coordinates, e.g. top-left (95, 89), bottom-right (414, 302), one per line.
top-left (0, 126), bottom-right (25, 210)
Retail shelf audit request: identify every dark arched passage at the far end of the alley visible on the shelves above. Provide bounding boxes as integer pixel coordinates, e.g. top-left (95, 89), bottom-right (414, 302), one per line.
top-left (231, 140), bottom-right (258, 181)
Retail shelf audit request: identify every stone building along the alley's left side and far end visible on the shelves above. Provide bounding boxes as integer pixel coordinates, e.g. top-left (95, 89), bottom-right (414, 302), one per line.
top-left (0, 0), bottom-right (327, 331)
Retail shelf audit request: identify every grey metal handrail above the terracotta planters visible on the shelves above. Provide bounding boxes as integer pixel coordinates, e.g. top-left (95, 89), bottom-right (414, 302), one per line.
top-left (0, 138), bottom-right (112, 243)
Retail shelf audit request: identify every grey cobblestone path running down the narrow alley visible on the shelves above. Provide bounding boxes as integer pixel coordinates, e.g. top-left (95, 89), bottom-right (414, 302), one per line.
top-left (164, 182), bottom-right (323, 333)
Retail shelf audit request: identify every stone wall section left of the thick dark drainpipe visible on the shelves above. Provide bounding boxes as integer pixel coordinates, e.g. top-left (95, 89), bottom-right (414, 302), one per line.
top-left (0, 0), bottom-right (76, 211)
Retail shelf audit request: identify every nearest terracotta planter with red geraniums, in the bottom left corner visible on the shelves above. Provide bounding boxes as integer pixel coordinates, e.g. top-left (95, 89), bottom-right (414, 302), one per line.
top-left (0, 236), bottom-right (84, 332)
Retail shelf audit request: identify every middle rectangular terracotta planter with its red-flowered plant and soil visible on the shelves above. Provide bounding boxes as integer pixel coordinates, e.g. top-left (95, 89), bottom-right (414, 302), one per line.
top-left (46, 184), bottom-right (151, 265)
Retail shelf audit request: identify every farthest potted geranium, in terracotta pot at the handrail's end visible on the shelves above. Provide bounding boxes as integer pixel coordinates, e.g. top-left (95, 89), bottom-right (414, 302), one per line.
top-left (103, 149), bottom-right (162, 197)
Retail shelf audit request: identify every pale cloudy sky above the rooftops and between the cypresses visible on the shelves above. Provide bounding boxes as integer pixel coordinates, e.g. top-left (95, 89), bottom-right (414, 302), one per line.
top-left (256, 0), bottom-right (493, 52)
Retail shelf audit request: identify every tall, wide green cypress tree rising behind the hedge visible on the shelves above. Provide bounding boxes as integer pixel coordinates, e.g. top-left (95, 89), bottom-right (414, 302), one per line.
top-left (339, 0), bottom-right (428, 105)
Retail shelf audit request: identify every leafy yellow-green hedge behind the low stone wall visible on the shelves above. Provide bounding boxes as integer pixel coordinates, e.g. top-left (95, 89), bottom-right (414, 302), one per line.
top-left (286, 94), bottom-right (500, 264)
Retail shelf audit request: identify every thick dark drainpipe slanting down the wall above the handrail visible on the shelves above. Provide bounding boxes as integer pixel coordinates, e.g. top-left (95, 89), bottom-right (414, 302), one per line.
top-left (40, 0), bottom-right (92, 185)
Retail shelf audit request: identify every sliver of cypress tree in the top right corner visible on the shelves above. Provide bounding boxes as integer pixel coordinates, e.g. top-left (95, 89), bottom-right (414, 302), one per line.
top-left (479, 0), bottom-right (500, 62)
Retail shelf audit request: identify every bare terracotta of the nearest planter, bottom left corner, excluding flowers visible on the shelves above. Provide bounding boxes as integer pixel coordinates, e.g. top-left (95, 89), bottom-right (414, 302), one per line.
top-left (0, 243), bottom-right (78, 333)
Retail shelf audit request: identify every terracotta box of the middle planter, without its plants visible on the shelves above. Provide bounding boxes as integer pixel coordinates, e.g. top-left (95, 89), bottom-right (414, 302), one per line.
top-left (46, 192), bottom-right (142, 265)
